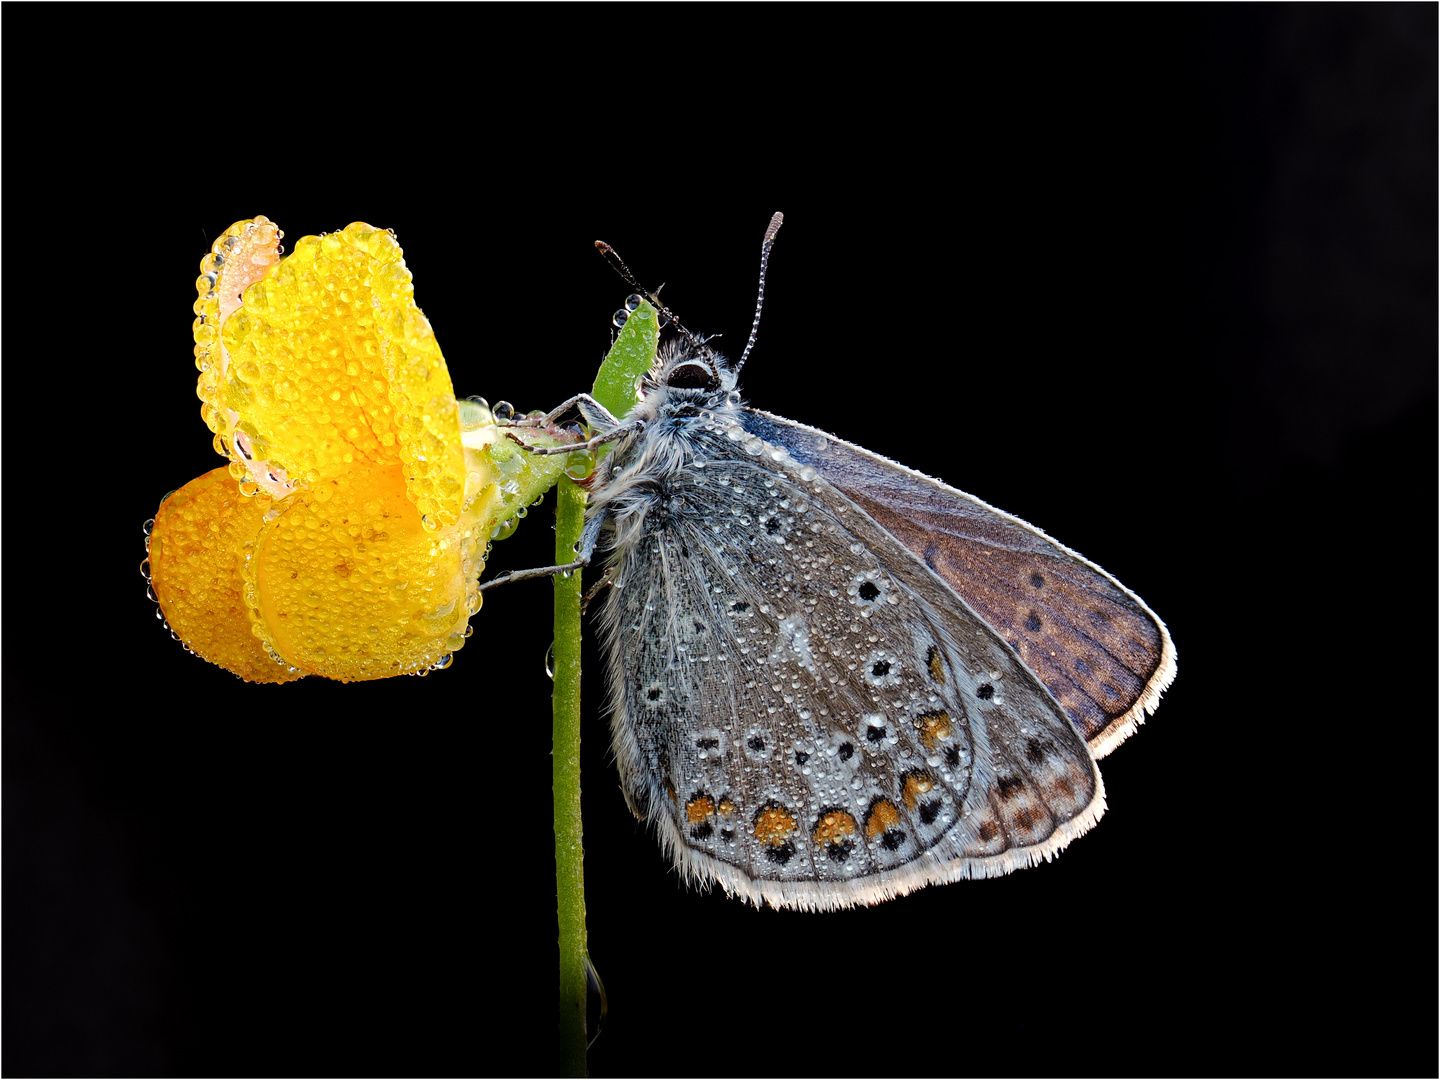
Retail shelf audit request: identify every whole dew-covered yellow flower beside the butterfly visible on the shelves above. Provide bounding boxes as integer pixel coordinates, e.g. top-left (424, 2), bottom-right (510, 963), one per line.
top-left (148, 217), bottom-right (560, 683)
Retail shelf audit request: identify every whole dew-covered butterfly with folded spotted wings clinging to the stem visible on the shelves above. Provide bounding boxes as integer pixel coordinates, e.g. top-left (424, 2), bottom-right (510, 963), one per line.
top-left (495, 215), bottom-right (1175, 910)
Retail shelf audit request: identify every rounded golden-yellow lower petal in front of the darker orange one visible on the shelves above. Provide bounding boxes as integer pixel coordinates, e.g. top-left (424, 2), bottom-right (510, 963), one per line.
top-left (252, 464), bottom-right (492, 683)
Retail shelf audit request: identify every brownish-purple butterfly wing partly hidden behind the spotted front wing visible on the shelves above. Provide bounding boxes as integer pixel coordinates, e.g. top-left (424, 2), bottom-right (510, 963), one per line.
top-left (742, 409), bottom-right (1175, 757)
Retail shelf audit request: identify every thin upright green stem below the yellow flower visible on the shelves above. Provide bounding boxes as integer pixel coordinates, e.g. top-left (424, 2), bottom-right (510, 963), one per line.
top-left (552, 478), bottom-right (586, 1076)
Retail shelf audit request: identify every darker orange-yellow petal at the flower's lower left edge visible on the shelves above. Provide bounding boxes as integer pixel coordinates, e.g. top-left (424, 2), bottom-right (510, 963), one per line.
top-left (150, 468), bottom-right (301, 683)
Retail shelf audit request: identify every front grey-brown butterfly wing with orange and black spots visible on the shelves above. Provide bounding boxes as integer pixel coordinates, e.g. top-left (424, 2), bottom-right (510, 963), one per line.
top-left (596, 425), bottom-right (1104, 909)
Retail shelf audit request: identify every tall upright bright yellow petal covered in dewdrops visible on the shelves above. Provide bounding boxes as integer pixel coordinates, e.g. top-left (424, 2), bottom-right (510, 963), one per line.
top-left (210, 219), bottom-right (465, 528)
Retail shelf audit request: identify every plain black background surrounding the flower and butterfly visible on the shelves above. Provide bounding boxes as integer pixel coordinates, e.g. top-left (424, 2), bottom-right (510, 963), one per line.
top-left (3, 6), bottom-right (1437, 1076)
